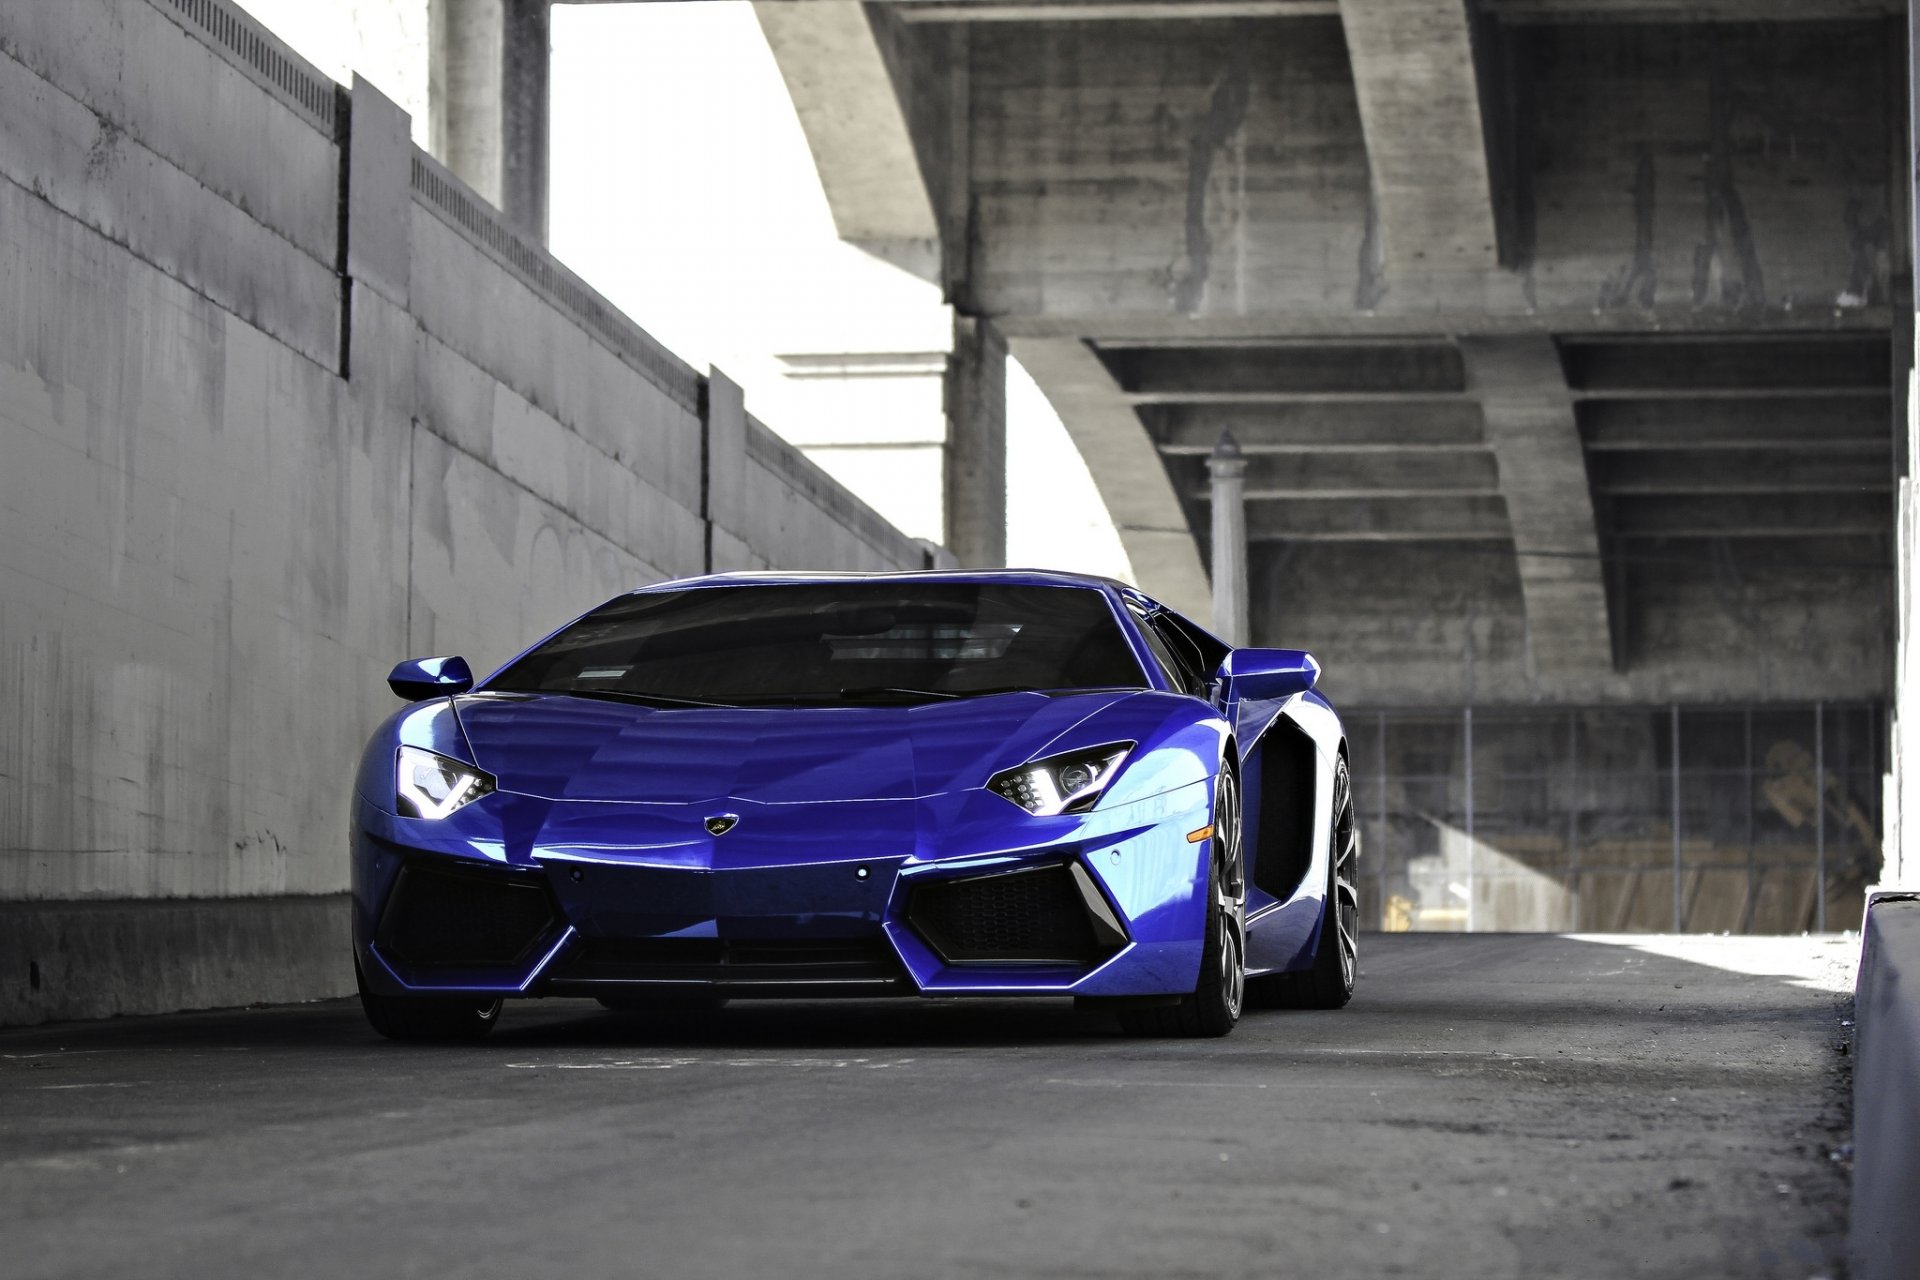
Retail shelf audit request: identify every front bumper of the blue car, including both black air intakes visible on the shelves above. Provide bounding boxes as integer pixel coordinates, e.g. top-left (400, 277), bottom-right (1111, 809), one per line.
top-left (353, 783), bottom-right (1210, 998)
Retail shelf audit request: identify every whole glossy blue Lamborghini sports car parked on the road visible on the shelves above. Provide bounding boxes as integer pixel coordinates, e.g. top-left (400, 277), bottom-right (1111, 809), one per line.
top-left (351, 570), bottom-right (1359, 1038)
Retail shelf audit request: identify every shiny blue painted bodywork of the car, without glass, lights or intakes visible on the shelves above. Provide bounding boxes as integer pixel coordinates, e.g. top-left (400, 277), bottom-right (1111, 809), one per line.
top-left (351, 572), bottom-right (1342, 996)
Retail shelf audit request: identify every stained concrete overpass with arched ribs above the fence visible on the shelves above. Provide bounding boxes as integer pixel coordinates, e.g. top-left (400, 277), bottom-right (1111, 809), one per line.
top-left (741, 0), bottom-right (1910, 704)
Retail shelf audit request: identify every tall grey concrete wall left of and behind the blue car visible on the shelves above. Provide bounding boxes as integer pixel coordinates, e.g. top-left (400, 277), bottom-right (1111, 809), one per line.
top-left (0, 0), bottom-right (925, 1023)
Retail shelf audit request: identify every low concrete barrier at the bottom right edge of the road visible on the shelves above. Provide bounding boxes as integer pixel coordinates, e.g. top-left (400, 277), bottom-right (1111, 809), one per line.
top-left (1849, 892), bottom-right (1920, 1280)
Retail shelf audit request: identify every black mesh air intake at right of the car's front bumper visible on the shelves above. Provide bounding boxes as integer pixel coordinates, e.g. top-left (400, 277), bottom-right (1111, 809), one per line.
top-left (906, 864), bottom-right (1127, 967)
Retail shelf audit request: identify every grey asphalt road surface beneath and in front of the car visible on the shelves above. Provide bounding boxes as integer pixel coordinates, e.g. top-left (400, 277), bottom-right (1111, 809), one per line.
top-left (0, 935), bottom-right (1857, 1280)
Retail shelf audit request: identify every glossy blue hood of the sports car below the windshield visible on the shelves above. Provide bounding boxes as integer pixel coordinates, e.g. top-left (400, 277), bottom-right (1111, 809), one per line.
top-left (455, 691), bottom-right (1137, 804)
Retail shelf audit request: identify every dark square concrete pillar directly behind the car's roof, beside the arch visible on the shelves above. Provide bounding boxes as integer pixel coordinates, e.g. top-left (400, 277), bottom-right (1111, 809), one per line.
top-left (947, 315), bottom-right (1006, 568)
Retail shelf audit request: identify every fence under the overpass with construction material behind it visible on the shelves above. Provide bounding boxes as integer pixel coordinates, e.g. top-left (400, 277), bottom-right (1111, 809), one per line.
top-left (1346, 702), bottom-right (1887, 933)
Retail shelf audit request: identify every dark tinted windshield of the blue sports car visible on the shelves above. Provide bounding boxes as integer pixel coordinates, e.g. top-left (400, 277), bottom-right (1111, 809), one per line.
top-left (488, 581), bottom-right (1144, 706)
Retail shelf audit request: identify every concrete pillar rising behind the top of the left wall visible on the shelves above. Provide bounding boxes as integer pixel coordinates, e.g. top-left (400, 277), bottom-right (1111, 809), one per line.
top-left (430, 0), bottom-right (551, 244)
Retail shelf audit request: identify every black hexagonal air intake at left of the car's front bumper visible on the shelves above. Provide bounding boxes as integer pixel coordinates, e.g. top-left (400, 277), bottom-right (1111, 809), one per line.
top-left (374, 862), bottom-right (557, 969)
